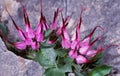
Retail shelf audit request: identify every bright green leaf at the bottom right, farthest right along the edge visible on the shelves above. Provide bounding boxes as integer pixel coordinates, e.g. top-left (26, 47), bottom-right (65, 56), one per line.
top-left (89, 65), bottom-right (112, 76)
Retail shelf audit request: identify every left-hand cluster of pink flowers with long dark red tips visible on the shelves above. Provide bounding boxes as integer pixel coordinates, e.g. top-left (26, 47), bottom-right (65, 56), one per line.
top-left (6, 4), bottom-right (47, 50)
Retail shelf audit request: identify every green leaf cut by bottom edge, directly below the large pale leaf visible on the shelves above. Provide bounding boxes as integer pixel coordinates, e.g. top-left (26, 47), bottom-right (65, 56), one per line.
top-left (44, 68), bottom-right (65, 76)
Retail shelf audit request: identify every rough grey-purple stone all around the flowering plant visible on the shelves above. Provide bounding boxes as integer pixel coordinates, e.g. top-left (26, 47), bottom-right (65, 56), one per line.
top-left (0, 0), bottom-right (120, 76)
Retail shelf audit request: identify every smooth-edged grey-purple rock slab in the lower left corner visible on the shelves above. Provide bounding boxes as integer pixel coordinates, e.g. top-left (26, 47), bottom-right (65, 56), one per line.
top-left (0, 38), bottom-right (44, 76)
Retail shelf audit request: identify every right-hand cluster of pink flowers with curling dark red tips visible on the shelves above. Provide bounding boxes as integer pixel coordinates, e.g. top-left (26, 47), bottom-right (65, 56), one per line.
top-left (68, 10), bottom-right (104, 64)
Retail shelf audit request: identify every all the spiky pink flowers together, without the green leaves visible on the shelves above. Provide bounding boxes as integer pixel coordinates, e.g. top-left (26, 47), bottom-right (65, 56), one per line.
top-left (7, 1), bottom-right (104, 64)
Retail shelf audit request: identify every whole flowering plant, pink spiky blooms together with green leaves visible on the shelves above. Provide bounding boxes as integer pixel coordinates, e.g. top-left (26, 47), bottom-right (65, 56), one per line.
top-left (0, 0), bottom-right (113, 76)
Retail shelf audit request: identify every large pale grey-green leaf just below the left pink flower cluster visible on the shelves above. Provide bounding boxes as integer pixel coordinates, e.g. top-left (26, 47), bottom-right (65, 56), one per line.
top-left (36, 48), bottom-right (57, 68)
